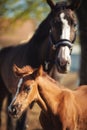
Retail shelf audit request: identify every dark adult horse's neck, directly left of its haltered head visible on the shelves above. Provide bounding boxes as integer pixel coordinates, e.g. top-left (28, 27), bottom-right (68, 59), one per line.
top-left (27, 13), bottom-right (52, 67)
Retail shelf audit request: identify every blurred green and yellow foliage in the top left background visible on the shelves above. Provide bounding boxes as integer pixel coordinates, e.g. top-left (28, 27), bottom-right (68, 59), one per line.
top-left (0, 0), bottom-right (49, 19)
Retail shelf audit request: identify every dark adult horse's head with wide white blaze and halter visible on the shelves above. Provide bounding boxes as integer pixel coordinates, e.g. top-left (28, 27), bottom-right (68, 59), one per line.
top-left (44, 0), bottom-right (79, 73)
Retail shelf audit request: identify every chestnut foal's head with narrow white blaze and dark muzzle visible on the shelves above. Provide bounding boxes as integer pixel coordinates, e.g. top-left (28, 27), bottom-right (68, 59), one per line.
top-left (8, 65), bottom-right (42, 118)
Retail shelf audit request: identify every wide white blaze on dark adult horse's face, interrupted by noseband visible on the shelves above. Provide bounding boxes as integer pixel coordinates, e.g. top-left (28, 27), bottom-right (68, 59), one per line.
top-left (58, 13), bottom-right (71, 65)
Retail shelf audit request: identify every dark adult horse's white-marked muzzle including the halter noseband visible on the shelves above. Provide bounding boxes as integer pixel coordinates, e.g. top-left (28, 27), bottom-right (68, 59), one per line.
top-left (53, 39), bottom-right (73, 73)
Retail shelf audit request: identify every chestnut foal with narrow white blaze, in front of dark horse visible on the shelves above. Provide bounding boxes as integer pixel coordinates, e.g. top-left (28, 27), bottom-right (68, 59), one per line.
top-left (8, 66), bottom-right (87, 130)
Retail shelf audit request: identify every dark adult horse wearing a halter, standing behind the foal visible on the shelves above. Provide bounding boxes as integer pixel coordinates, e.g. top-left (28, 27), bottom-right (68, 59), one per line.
top-left (0, 0), bottom-right (79, 130)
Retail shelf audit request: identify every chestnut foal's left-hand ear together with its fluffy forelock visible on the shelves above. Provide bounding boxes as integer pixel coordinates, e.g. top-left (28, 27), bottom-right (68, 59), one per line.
top-left (13, 64), bottom-right (33, 76)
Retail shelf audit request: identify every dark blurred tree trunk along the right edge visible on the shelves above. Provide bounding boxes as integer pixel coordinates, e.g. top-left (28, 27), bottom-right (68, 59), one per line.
top-left (76, 0), bottom-right (87, 85)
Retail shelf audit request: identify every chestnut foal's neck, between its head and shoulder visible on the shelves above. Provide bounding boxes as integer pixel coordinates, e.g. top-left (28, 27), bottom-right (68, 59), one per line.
top-left (37, 74), bottom-right (62, 113)
